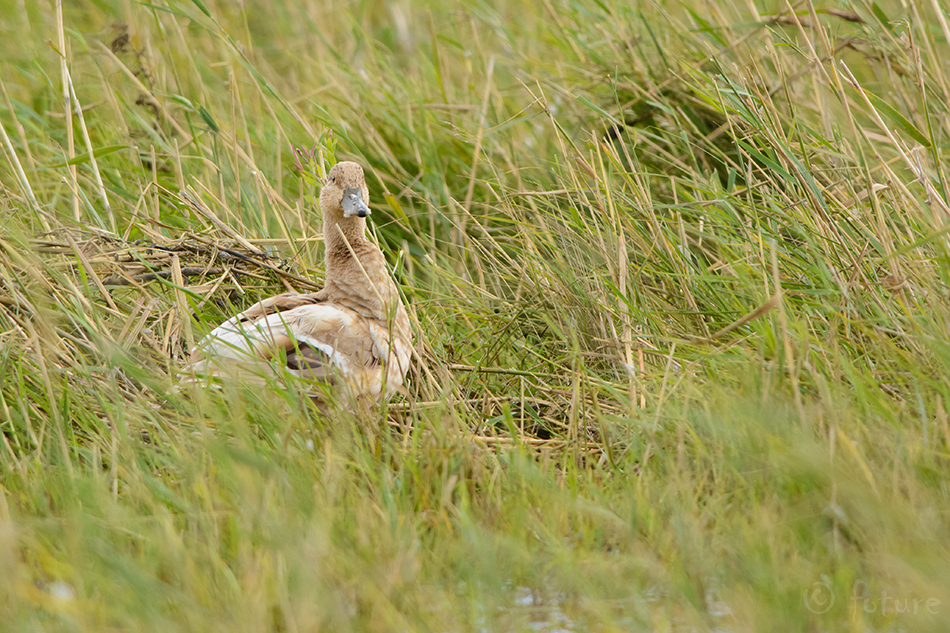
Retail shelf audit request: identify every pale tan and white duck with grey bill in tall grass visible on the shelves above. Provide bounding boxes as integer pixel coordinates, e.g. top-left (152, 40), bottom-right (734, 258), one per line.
top-left (190, 161), bottom-right (414, 400)
